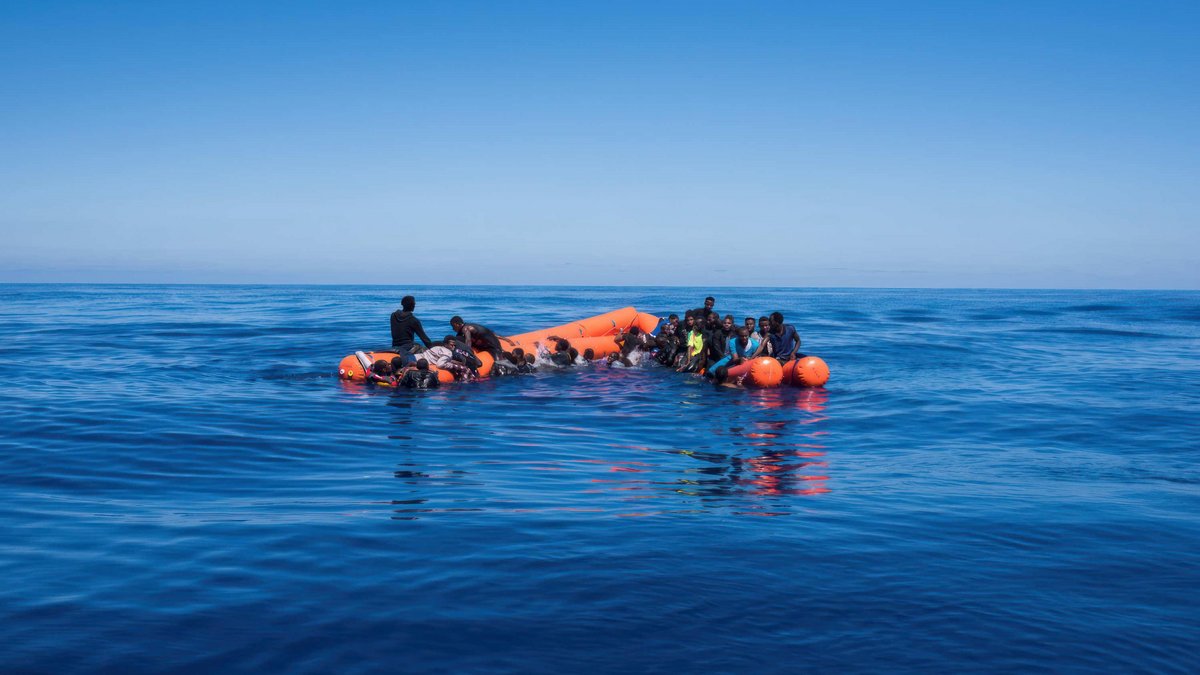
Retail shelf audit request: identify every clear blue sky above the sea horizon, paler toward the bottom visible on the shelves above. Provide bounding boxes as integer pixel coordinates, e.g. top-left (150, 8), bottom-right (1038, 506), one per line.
top-left (0, 1), bottom-right (1200, 288)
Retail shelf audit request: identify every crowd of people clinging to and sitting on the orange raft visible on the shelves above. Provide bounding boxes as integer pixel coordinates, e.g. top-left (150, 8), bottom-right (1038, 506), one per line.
top-left (368, 295), bottom-right (804, 389)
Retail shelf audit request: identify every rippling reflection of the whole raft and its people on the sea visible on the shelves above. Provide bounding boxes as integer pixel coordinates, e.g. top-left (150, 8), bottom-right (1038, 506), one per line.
top-left (372, 369), bottom-right (830, 520)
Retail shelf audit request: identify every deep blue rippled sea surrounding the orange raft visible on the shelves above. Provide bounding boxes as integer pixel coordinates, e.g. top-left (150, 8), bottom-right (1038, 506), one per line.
top-left (0, 281), bottom-right (1200, 673)
